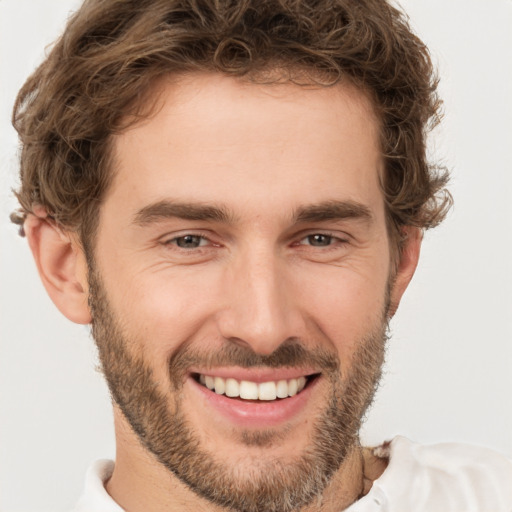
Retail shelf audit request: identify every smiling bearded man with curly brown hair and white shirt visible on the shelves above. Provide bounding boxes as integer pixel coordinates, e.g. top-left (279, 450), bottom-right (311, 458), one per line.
top-left (7, 2), bottom-right (511, 511)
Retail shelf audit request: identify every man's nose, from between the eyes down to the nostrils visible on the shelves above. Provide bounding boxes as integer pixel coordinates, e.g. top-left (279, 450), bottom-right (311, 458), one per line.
top-left (217, 246), bottom-right (302, 355)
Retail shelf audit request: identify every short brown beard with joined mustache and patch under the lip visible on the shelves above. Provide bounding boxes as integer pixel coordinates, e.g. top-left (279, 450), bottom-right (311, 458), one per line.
top-left (89, 264), bottom-right (389, 512)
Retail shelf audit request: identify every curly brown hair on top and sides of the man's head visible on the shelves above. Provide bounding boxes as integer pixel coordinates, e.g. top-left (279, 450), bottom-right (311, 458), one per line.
top-left (11, 0), bottom-right (451, 250)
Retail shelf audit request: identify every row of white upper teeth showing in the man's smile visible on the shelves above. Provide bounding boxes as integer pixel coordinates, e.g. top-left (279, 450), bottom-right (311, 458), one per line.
top-left (199, 375), bottom-right (306, 400)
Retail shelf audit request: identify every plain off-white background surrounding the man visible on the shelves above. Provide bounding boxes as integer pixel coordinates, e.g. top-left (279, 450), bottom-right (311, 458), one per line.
top-left (0, 0), bottom-right (512, 512)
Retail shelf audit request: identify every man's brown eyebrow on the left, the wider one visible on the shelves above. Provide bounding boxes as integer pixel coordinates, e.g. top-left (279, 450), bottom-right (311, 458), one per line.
top-left (134, 200), bottom-right (233, 226)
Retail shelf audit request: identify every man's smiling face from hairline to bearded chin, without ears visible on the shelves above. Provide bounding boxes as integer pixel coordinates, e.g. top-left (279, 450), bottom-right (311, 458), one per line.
top-left (89, 75), bottom-right (395, 511)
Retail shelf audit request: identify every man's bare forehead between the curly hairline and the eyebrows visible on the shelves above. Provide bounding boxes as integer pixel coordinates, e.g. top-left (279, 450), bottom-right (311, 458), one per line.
top-left (106, 74), bottom-right (382, 224)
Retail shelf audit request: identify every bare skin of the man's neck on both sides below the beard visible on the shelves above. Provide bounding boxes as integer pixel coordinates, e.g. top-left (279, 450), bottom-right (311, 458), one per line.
top-left (106, 411), bottom-right (375, 512)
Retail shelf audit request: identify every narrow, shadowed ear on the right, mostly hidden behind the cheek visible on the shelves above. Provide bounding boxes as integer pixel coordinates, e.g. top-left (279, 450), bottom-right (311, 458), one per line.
top-left (388, 226), bottom-right (423, 318)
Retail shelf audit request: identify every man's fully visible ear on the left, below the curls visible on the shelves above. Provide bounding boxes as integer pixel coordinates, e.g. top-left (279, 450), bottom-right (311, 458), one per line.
top-left (24, 211), bottom-right (91, 324)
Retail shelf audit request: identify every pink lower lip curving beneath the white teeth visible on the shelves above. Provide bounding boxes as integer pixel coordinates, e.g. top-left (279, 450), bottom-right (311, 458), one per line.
top-left (188, 377), bottom-right (320, 428)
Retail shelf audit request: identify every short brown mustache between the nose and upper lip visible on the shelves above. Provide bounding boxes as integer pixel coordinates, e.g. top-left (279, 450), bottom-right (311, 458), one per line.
top-left (168, 338), bottom-right (340, 387)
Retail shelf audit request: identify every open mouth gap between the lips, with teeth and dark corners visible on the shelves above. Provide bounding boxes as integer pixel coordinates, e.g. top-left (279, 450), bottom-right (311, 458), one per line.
top-left (192, 373), bottom-right (319, 402)
